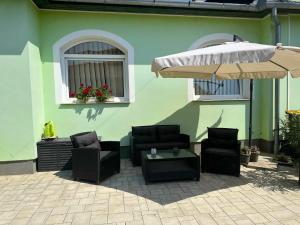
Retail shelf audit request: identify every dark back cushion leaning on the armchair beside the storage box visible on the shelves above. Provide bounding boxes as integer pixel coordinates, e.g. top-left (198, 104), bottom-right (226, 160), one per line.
top-left (71, 131), bottom-right (101, 149)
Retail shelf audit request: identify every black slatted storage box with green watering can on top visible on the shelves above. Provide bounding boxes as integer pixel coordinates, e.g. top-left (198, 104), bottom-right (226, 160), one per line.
top-left (37, 138), bottom-right (73, 172)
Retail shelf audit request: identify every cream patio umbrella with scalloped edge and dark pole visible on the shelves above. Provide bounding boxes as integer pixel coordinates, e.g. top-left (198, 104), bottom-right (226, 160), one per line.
top-left (152, 42), bottom-right (300, 148)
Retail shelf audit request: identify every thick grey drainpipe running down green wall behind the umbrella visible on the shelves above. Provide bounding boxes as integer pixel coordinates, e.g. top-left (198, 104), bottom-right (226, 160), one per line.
top-left (272, 7), bottom-right (281, 155)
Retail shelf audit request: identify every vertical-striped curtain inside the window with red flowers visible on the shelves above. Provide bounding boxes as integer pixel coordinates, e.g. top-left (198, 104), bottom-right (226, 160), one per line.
top-left (65, 41), bottom-right (124, 97)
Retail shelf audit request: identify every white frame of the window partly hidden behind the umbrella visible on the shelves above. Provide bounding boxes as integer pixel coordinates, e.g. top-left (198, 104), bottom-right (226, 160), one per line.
top-left (188, 33), bottom-right (250, 101)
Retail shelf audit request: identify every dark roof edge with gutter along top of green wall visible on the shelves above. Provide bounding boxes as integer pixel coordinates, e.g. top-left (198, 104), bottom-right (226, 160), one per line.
top-left (33, 0), bottom-right (300, 18)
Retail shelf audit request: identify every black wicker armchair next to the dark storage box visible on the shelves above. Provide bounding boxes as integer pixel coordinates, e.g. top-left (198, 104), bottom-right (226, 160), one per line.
top-left (70, 132), bottom-right (120, 184)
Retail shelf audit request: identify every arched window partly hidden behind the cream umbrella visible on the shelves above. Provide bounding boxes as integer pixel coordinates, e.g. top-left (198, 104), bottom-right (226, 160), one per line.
top-left (188, 34), bottom-right (249, 100)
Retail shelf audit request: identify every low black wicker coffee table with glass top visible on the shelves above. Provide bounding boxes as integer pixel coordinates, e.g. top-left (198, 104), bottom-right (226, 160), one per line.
top-left (141, 149), bottom-right (200, 184)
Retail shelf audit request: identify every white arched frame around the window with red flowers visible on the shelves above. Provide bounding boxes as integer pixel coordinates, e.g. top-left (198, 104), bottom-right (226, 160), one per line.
top-left (53, 30), bottom-right (135, 104)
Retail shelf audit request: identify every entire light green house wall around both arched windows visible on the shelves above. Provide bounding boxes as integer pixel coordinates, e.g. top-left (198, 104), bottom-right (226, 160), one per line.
top-left (0, 0), bottom-right (300, 161)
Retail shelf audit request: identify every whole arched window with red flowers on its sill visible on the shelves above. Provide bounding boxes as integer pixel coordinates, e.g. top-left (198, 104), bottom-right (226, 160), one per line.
top-left (54, 30), bottom-right (134, 104)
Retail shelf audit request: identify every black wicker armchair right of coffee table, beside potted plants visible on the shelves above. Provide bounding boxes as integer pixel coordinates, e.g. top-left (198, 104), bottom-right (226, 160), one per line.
top-left (201, 128), bottom-right (241, 176)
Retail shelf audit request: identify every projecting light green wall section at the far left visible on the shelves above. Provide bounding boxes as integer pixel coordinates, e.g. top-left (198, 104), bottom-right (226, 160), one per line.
top-left (0, 0), bottom-right (44, 161)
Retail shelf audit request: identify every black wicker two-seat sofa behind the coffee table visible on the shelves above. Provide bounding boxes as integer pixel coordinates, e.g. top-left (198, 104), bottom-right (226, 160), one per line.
top-left (130, 125), bottom-right (190, 166)
